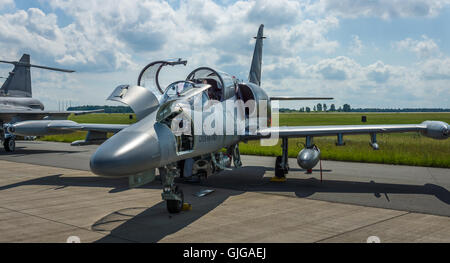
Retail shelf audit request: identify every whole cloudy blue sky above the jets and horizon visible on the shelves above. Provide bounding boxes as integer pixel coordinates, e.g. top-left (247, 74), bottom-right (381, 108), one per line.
top-left (0, 0), bottom-right (450, 109)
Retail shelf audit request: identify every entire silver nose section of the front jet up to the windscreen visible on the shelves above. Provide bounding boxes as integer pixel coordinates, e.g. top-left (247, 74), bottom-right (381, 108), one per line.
top-left (90, 113), bottom-right (178, 177)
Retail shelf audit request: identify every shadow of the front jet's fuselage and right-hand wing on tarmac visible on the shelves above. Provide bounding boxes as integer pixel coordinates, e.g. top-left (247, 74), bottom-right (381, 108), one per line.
top-left (92, 167), bottom-right (450, 242)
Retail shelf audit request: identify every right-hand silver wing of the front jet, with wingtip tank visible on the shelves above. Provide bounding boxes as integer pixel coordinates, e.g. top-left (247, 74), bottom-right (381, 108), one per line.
top-left (258, 121), bottom-right (449, 139)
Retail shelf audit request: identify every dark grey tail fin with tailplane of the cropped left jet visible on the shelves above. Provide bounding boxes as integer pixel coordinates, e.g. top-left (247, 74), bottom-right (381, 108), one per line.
top-left (0, 54), bottom-right (74, 98)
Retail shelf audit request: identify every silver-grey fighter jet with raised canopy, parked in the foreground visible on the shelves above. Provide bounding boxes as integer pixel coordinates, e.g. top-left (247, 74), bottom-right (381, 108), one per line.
top-left (9, 25), bottom-right (449, 213)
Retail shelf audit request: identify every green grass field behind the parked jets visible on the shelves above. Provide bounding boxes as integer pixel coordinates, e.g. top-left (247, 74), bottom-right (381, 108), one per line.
top-left (39, 113), bottom-right (450, 168)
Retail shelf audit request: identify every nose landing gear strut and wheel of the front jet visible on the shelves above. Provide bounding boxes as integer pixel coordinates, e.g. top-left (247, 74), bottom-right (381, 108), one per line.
top-left (159, 166), bottom-right (184, 214)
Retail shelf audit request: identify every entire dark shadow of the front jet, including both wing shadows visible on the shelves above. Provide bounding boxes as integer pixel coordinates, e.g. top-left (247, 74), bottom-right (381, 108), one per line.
top-left (0, 167), bottom-right (450, 242)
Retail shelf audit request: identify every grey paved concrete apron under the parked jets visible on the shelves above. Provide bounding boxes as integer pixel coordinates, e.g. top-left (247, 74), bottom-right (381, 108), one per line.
top-left (0, 142), bottom-right (450, 242)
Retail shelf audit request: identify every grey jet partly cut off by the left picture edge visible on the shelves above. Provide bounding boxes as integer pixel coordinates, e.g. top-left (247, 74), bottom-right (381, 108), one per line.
top-left (0, 54), bottom-right (102, 152)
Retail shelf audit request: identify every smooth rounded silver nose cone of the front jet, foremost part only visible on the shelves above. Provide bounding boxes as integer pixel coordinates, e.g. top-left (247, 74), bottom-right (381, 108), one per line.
top-left (90, 130), bottom-right (161, 177)
